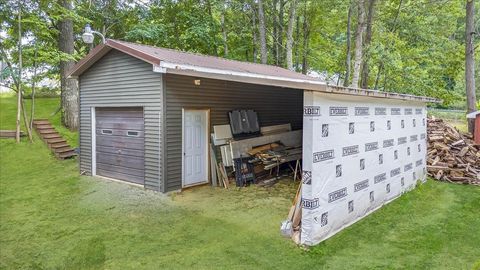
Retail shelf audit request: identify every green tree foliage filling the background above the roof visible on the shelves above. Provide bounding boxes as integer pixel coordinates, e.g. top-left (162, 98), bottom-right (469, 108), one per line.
top-left (0, 0), bottom-right (480, 106)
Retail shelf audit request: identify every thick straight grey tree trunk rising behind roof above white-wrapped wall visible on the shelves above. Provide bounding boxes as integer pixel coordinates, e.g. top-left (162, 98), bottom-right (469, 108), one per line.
top-left (350, 0), bottom-right (365, 88)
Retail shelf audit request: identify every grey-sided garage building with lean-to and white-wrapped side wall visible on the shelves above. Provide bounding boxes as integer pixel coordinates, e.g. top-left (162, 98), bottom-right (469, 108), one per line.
top-left (70, 40), bottom-right (436, 245)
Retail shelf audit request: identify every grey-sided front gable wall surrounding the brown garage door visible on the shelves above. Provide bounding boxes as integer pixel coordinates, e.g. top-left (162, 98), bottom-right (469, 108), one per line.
top-left (79, 50), bottom-right (163, 191)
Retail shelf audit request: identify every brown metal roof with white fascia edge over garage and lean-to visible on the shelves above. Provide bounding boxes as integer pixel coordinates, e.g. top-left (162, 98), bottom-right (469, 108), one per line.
top-left (69, 39), bottom-right (440, 102)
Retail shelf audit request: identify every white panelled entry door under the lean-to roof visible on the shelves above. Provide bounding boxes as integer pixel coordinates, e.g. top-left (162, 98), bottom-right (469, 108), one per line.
top-left (183, 110), bottom-right (208, 186)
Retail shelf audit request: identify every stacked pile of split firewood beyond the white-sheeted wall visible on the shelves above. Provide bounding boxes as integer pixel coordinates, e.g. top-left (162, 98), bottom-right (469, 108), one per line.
top-left (427, 118), bottom-right (480, 185)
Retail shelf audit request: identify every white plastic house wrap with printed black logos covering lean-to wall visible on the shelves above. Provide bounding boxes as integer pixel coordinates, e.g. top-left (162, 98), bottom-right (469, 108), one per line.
top-left (300, 91), bottom-right (426, 245)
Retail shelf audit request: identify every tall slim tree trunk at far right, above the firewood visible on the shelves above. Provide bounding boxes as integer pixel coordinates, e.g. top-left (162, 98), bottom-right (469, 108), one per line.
top-left (465, 0), bottom-right (477, 133)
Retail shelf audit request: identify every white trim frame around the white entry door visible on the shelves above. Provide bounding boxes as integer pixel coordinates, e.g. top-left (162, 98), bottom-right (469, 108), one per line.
top-left (182, 108), bottom-right (210, 188)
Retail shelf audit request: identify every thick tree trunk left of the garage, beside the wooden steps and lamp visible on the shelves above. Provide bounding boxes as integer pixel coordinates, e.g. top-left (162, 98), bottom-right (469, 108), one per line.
top-left (58, 0), bottom-right (78, 130)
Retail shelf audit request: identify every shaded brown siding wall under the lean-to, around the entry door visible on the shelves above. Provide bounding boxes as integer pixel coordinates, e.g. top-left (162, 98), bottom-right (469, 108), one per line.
top-left (164, 74), bottom-right (303, 191)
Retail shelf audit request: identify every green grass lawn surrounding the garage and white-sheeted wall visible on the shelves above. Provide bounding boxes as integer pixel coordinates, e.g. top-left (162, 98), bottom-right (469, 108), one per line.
top-left (0, 98), bottom-right (480, 269)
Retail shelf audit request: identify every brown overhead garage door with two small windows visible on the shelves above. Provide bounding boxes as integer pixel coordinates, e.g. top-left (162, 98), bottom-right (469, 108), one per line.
top-left (95, 108), bottom-right (145, 184)
